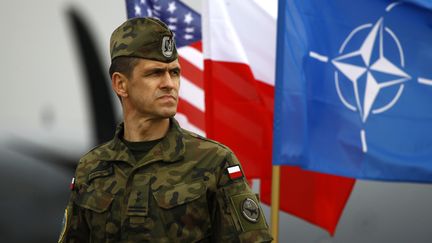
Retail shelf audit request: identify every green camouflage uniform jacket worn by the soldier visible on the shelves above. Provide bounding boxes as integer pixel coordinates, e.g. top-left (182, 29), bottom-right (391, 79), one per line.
top-left (59, 119), bottom-right (272, 243)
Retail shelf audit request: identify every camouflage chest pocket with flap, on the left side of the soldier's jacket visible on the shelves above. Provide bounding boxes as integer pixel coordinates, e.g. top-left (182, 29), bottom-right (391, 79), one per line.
top-left (75, 186), bottom-right (114, 242)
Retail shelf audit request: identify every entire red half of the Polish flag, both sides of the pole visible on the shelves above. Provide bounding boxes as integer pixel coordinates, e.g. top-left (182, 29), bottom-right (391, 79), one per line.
top-left (204, 60), bottom-right (355, 234)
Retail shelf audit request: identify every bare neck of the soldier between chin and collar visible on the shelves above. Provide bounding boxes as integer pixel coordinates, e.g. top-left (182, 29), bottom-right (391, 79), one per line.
top-left (123, 117), bottom-right (169, 142)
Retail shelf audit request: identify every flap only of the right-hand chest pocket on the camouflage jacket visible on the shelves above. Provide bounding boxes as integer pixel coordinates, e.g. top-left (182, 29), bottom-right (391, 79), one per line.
top-left (153, 181), bottom-right (206, 209)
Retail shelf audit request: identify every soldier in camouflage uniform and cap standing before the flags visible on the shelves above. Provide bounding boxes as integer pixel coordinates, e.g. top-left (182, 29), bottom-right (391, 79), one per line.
top-left (59, 18), bottom-right (272, 243)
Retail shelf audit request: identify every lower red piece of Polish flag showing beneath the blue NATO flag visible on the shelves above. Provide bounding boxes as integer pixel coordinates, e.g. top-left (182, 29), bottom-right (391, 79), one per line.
top-left (280, 166), bottom-right (355, 235)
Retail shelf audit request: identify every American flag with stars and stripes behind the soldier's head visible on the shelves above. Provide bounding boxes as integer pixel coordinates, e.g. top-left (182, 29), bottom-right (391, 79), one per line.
top-left (126, 0), bottom-right (205, 136)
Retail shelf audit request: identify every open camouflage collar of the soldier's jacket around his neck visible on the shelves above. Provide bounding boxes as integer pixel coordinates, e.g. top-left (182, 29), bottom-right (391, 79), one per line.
top-left (101, 118), bottom-right (185, 165)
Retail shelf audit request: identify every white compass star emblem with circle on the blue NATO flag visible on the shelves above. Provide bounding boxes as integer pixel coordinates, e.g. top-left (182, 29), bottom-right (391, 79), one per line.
top-left (309, 2), bottom-right (432, 153)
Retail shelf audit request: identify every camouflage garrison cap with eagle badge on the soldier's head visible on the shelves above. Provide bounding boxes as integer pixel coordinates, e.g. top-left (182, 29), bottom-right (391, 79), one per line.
top-left (110, 17), bottom-right (177, 63)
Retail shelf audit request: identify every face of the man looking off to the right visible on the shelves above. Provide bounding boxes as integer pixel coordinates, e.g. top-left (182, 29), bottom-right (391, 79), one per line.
top-left (127, 59), bottom-right (180, 119)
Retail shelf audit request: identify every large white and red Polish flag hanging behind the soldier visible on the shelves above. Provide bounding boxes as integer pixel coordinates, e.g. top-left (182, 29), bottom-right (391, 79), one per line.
top-left (202, 0), bottom-right (355, 234)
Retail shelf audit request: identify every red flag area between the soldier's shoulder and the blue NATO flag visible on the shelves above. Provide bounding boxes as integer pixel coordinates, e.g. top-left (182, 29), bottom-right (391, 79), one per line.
top-left (205, 60), bottom-right (273, 178)
